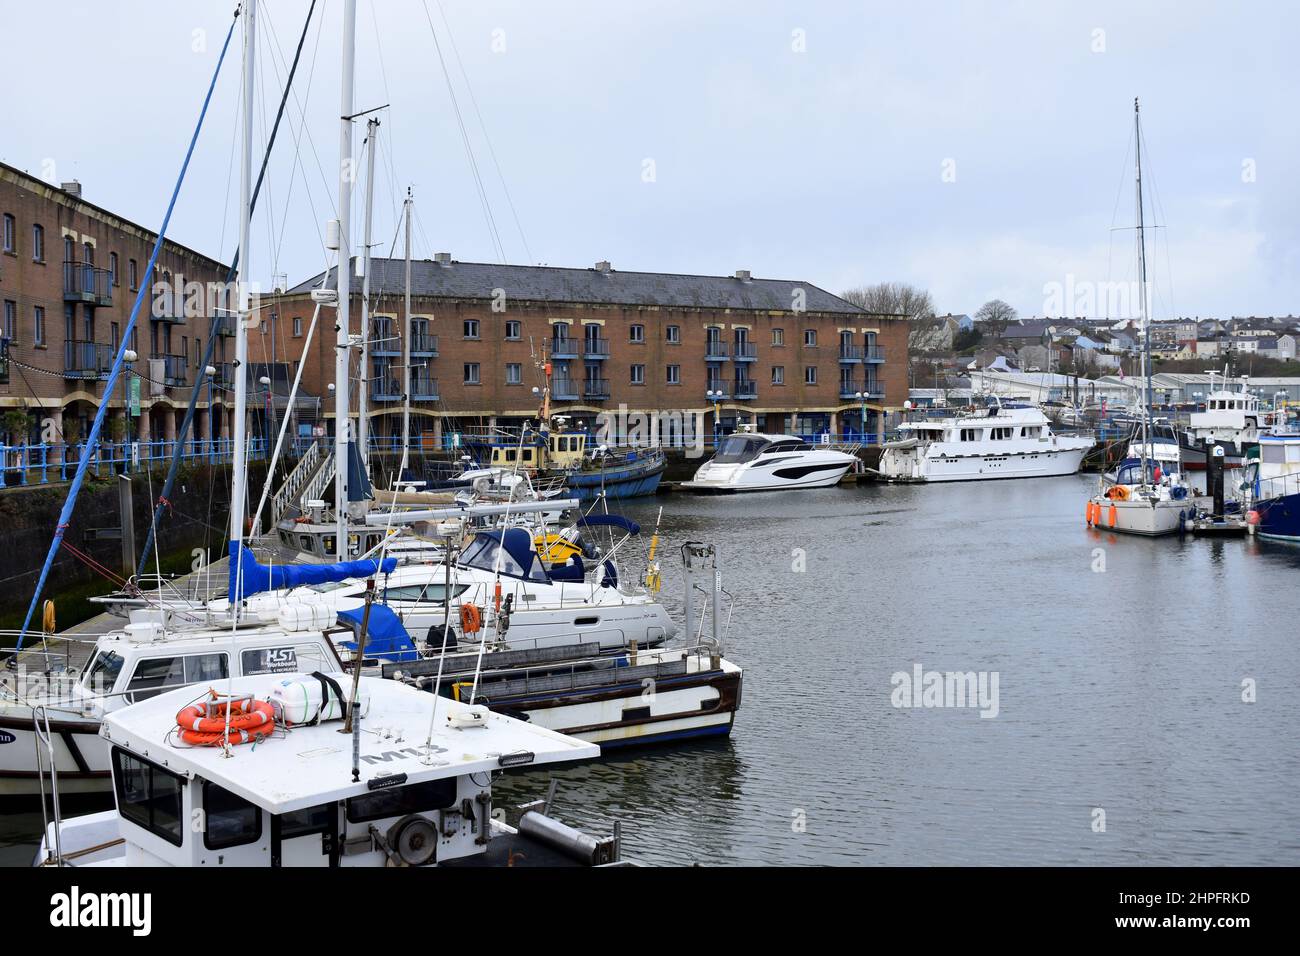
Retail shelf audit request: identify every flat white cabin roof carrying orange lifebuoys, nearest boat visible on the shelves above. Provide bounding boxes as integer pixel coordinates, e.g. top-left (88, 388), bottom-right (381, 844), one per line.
top-left (100, 674), bottom-right (601, 814)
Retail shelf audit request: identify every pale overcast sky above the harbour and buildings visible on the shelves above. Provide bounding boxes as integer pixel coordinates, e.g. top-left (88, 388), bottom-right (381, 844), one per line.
top-left (0, 0), bottom-right (1300, 319)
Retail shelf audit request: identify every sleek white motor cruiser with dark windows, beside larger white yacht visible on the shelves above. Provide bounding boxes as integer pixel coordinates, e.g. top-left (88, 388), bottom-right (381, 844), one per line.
top-left (681, 432), bottom-right (858, 493)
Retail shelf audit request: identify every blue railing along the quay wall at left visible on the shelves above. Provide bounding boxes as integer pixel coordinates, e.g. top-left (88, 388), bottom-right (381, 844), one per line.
top-left (0, 438), bottom-right (267, 488)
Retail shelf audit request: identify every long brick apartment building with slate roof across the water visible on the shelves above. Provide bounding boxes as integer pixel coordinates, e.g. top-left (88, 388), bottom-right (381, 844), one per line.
top-left (273, 254), bottom-right (907, 444)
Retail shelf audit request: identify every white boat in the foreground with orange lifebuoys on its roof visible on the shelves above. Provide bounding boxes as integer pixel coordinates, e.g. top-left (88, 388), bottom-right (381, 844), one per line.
top-left (36, 672), bottom-right (631, 868)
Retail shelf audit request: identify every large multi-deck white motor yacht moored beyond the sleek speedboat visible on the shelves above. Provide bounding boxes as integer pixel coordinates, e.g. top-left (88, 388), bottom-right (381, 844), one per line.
top-left (878, 403), bottom-right (1095, 481)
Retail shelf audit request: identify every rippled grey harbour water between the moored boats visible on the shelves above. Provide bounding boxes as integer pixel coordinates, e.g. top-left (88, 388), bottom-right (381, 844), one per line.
top-left (0, 476), bottom-right (1300, 865)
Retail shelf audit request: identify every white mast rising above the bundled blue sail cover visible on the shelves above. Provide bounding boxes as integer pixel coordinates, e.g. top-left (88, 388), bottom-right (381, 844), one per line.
top-left (230, 0), bottom-right (257, 548)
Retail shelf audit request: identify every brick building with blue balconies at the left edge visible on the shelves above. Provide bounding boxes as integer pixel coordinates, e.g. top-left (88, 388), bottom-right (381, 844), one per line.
top-left (0, 164), bottom-right (234, 445)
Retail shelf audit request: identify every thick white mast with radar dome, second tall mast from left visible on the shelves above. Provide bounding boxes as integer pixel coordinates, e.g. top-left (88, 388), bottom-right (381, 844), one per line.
top-left (334, 0), bottom-right (356, 561)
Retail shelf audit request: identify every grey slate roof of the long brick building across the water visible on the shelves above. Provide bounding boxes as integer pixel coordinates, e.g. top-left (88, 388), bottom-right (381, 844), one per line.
top-left (289, 259), bottom-right (866, 315)
